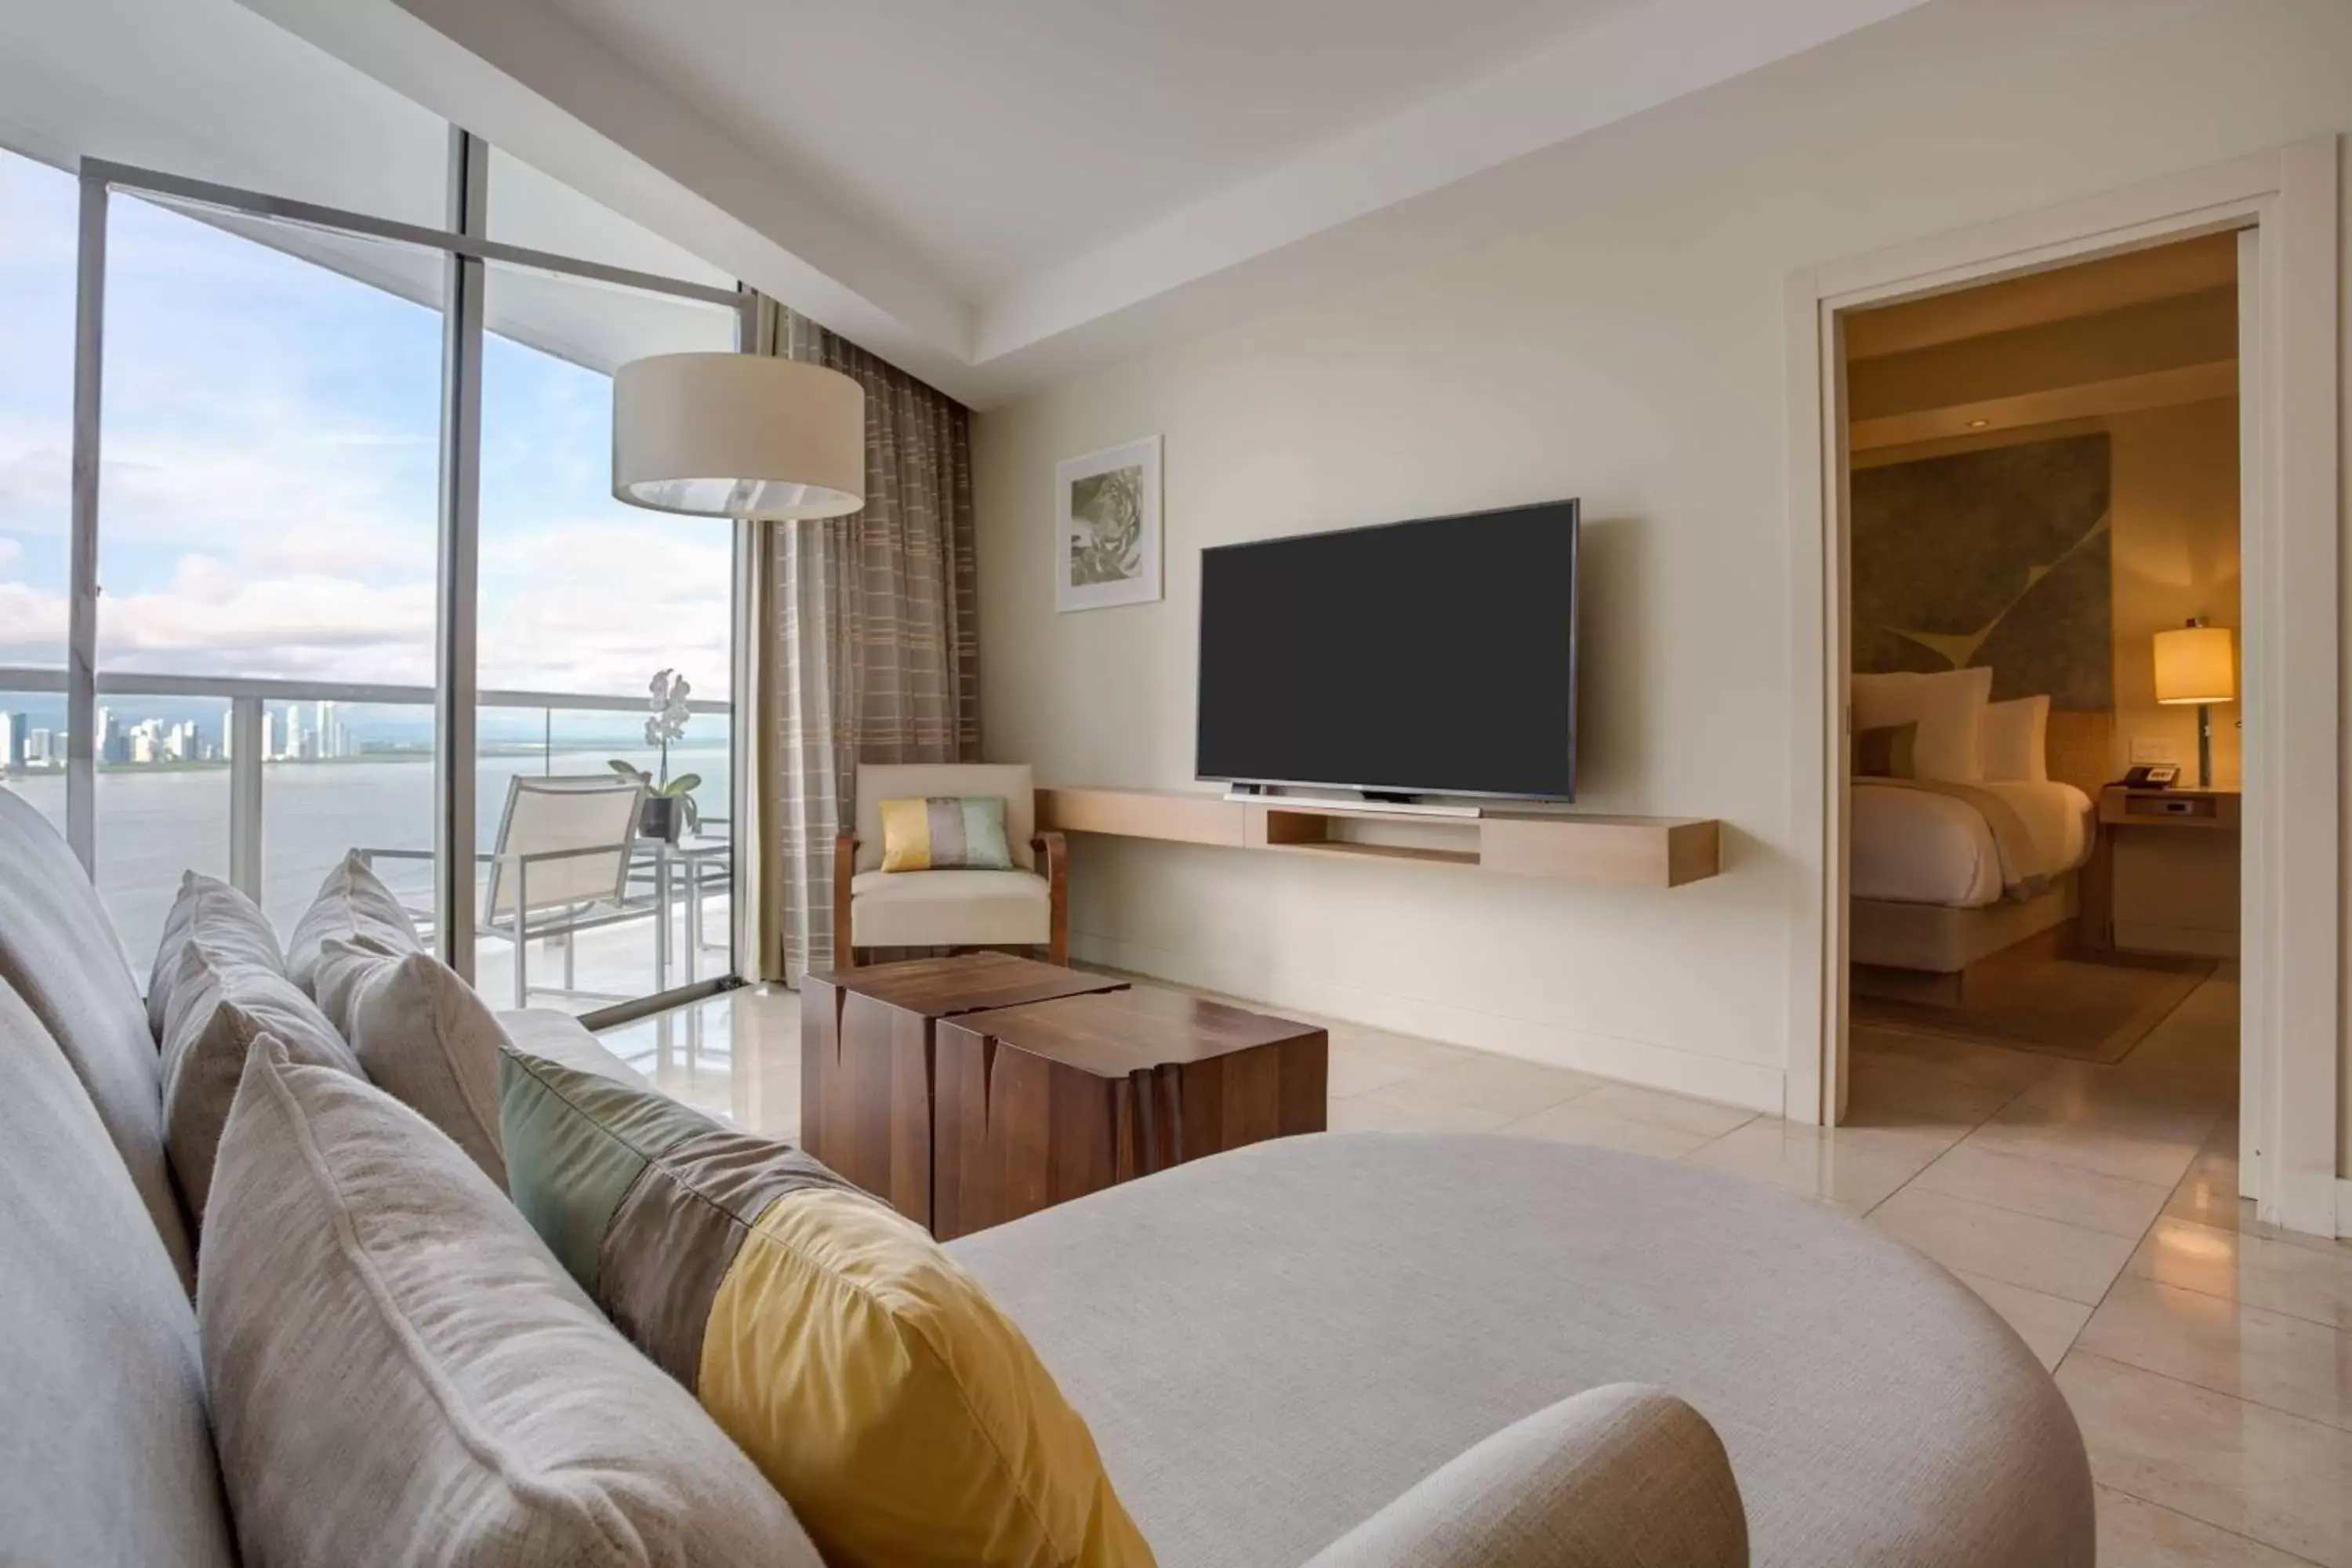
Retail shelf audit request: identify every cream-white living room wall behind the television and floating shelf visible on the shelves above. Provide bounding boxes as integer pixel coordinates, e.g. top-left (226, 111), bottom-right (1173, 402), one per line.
top-left (976, 0), bottom-right (2352, 1109)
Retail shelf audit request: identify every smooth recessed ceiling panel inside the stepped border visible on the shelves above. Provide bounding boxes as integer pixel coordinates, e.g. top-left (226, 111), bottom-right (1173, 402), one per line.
top-left (539, 0), bottom-right (1639, 299)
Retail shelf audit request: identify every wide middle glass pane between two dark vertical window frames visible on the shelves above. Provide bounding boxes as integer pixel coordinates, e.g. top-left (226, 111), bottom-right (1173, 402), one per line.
top-left (96, 193), bottom-right (442, 954)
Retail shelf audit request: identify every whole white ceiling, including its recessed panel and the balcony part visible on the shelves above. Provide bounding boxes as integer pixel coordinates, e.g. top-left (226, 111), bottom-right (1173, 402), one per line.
top-left (0, 0), bottom-right (2206, 407)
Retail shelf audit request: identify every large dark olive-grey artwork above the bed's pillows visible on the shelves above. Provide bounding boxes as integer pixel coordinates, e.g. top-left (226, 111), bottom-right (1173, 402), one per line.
top-left (1851, 435), bottom-right (2114, 713)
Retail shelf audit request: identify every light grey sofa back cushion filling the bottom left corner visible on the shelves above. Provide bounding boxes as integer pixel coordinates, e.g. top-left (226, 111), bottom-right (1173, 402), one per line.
top-left (0, 985), bottom-right (235, 1568)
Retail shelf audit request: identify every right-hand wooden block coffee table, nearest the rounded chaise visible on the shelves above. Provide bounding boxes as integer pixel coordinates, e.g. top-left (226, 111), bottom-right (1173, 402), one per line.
top-left (931, 985), bottom-right (1331, 1241)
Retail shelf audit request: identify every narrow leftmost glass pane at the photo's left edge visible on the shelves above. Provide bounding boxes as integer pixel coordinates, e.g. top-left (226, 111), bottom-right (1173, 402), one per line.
top-left (0, 151), bottom-right (80, 846)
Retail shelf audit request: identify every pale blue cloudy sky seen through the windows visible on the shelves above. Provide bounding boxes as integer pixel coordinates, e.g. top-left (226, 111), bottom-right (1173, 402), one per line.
top-left (0, 151), bottom-right (731, 699)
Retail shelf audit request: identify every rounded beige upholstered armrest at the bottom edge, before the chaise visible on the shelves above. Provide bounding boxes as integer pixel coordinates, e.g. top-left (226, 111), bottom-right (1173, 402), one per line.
top-left (1308, 1382), bottom-right (1748, 1568)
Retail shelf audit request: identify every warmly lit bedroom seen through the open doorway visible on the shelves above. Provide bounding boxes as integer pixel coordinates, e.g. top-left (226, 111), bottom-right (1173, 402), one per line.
top-left (1844, 233), bottom-right (2244, 1128)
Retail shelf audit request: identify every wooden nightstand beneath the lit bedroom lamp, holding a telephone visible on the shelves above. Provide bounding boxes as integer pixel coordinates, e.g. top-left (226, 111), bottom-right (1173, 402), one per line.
top-left (2084, 785), bottom-right (2239, 959)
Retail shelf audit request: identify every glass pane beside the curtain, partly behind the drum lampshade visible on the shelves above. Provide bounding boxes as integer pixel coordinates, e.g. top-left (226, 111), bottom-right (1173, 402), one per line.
top-left (475, 262), bottom-right (736, 1008)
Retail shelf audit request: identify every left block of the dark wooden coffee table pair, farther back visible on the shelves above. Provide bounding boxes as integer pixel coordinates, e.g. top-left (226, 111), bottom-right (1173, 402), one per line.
top-left (800, 952), bottom-right (1127, 1225)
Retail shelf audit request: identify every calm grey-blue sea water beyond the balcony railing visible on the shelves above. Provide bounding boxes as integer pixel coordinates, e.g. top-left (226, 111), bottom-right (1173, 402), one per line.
top-left (7, 746), bottom-right (729, 975)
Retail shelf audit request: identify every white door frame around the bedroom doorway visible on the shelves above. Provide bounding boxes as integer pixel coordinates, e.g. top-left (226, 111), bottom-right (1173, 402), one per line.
top-left (1785, 136), bottom-right (2345, 1236)
